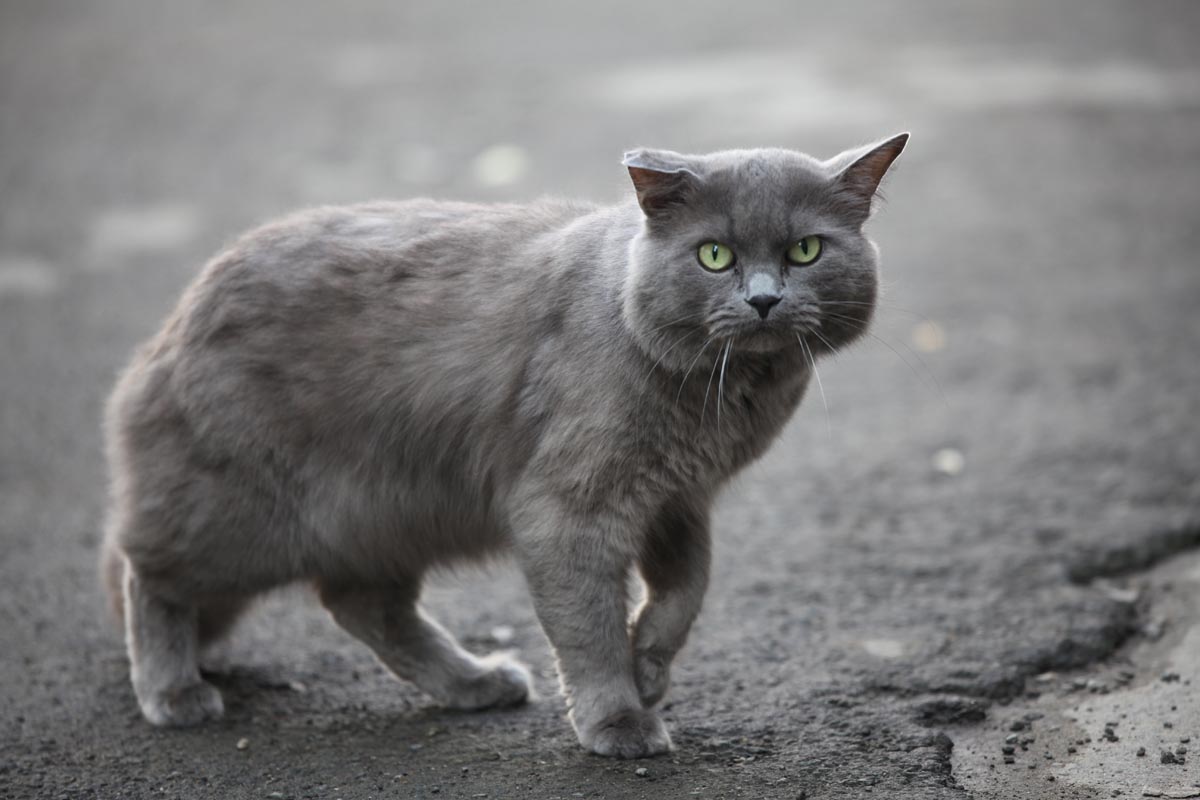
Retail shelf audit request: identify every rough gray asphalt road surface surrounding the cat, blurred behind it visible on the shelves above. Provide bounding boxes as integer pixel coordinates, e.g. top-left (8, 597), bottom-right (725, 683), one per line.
top-left (0, 0), bottom-right (1200, 799)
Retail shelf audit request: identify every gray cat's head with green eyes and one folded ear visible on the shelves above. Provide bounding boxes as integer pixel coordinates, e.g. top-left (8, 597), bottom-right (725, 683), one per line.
top-left (624, 133), bottom-right (908, 369)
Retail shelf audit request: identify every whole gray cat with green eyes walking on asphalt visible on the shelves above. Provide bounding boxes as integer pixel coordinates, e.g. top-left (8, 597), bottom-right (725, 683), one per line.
top-left (103, 134), bottom-right (907, 758)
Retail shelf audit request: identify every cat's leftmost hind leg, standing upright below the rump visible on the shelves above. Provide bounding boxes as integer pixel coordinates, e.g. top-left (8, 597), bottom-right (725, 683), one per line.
top-left (124, 566), bottom-right (224, 726)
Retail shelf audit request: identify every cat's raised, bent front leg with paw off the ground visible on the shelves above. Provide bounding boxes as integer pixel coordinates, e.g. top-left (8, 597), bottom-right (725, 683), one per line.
top-left (632, 501), bottom-right (710, 708)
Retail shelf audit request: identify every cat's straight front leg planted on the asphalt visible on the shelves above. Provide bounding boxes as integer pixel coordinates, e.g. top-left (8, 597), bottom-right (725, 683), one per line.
top-left (517, 499), bottom-right (671, 758)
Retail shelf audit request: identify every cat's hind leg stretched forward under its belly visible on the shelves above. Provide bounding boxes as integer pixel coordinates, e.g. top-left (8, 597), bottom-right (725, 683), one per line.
top-left (318, 581), bottom-right (532, 710)
